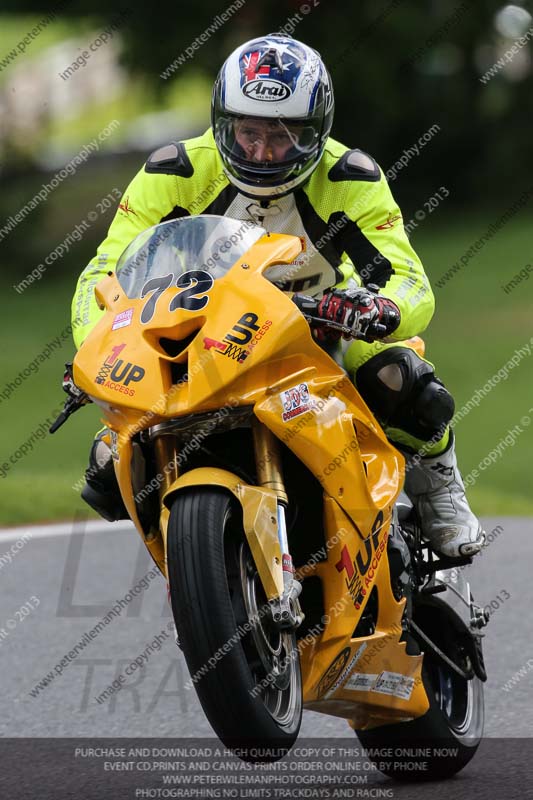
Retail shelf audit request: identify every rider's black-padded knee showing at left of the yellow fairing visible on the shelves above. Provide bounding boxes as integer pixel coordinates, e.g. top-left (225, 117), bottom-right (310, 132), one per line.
top-left (81, 428), bottom-right (130, 522)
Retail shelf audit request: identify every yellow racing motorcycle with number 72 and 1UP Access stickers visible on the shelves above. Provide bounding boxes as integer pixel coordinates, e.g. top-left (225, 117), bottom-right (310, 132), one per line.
top-left (52, 215), bottom-right (487, 779)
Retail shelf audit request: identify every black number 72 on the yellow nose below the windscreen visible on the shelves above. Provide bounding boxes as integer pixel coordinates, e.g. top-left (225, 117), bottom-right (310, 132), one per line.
top-left (141, 269), bottom-right (215, 324)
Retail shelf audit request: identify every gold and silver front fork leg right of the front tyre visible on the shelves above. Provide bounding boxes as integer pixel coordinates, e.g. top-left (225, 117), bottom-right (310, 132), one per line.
top-left (252, 418), bottom-right (305, 630)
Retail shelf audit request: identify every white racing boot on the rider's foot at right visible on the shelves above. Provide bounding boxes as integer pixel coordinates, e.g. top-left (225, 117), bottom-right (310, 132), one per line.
top-left (404, 430), bottom-right (485, 558)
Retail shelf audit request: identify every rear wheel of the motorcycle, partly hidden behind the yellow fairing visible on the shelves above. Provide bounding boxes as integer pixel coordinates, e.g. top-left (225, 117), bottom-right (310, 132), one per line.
top-left (356, 616), bottom-right (485, 781)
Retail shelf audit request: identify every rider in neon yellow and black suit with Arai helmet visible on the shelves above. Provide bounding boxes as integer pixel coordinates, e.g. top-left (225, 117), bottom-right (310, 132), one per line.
top-left (72, 34), bottom-right (484, 557)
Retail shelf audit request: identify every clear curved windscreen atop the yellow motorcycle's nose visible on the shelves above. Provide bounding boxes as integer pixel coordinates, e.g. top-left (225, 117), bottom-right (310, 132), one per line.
top-left (116, 214), bottom-right (266, 299)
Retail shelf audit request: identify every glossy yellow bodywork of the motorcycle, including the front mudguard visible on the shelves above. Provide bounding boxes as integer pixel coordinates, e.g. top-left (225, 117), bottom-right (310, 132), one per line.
top-left (74, 222), bottom-right (428, 728)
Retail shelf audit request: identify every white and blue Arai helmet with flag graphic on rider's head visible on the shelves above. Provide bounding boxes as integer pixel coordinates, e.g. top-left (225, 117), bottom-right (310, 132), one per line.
top-left (211, 34), bottom-right (334, 199)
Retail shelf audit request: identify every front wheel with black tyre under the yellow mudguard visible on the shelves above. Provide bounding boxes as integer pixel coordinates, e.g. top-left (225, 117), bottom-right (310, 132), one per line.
top-left (167, 488), bottom-right (302, 761)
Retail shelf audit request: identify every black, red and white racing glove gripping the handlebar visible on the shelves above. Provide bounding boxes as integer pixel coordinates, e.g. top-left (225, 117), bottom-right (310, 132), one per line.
top-left (318, 286), bottom-right (400, 342)
